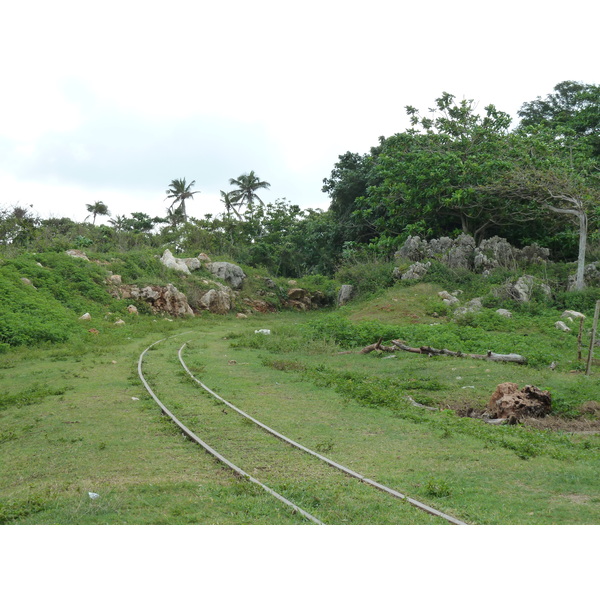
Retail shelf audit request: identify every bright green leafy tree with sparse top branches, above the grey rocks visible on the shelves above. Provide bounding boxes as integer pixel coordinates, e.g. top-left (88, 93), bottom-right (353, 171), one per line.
top-left (357, 93), bottom-right (532, 244)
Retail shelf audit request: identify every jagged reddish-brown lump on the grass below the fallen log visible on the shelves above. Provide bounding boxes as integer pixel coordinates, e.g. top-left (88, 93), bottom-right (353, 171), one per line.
top-left (487, 382), bottom-right (552, 419)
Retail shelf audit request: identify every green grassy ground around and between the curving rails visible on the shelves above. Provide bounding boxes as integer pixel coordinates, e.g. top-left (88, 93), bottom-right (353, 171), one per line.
top-left (0, 286), bottom-right (600, 524)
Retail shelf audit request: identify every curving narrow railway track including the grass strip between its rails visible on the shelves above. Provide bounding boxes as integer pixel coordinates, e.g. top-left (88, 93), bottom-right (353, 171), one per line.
top-left (138, 338), bottom-right (464, 524)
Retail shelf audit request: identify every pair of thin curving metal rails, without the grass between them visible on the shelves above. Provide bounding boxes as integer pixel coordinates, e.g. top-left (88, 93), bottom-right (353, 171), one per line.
top-left (138, 332), bottom-right (466, 525)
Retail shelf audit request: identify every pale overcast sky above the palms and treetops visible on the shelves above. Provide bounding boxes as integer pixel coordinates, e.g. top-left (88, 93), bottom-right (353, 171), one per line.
top-left (0, 0), bottom-right (600, 223)
